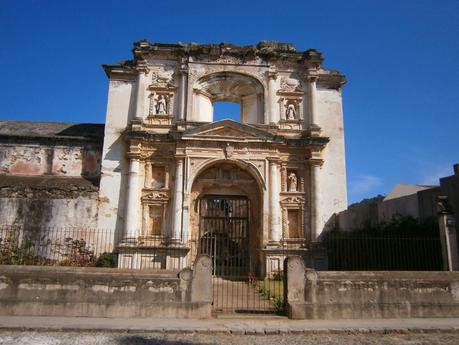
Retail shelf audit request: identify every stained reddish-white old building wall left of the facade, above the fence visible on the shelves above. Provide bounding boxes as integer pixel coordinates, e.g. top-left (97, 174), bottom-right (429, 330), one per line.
top-left (0, 121), bottom-right (104, 230)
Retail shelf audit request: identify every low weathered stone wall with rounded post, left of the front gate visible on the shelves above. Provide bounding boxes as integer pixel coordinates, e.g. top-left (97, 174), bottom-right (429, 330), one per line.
top-left (0, 256), bottom-right (212, 318)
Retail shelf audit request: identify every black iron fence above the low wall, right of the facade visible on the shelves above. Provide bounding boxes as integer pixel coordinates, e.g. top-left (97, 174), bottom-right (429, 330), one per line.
top-left (323, 232), bottom-right (443, 271)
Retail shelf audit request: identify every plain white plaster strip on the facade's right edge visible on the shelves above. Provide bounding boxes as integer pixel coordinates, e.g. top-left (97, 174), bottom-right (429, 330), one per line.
top-left (316, 88), bottom-right (347, 236)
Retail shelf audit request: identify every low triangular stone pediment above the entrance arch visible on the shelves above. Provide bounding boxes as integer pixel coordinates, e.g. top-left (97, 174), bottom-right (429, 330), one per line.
top-left (182, 120), bottom-right (274, 141)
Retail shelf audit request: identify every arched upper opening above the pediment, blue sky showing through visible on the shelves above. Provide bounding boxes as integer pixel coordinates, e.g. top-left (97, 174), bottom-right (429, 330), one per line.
top-left (190, 72), bottom-right (264, 124)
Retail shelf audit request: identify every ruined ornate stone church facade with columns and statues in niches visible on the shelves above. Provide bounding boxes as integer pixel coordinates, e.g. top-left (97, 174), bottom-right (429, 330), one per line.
top-left (97, 41), bottom-right (347, 274)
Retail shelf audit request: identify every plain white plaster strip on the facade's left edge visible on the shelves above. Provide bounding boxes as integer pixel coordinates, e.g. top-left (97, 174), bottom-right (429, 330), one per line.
top-left (98, 80), bottom-right (136, 232)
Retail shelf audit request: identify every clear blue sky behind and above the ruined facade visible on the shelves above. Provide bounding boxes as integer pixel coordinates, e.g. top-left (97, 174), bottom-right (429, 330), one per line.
top-left (0, 0), bottom-right (459, 202)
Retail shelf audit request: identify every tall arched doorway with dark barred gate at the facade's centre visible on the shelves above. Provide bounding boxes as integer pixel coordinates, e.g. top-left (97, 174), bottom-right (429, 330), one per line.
top-left (190, 161), bottom-right (263, 278)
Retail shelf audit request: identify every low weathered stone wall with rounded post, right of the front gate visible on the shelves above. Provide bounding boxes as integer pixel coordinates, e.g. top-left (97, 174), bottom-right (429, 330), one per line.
top-left (286, 257), bottom-right (459, 319)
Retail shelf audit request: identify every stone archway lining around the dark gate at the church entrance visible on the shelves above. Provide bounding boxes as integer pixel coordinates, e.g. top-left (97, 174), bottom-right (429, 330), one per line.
top-left (189, 161), bottom-right (263, 273)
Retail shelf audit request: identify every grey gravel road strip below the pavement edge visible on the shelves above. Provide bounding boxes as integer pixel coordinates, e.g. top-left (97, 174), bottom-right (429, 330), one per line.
top-left (0, 331), bottom-right (459, 345)
